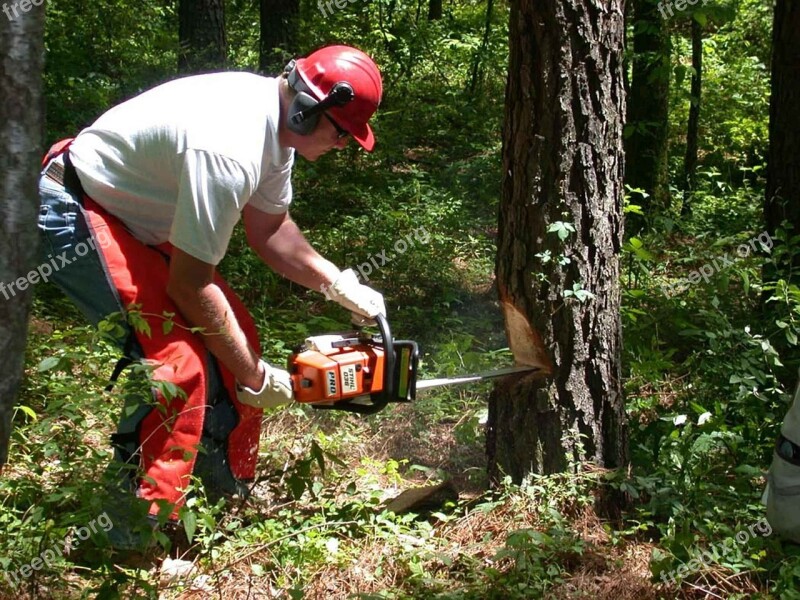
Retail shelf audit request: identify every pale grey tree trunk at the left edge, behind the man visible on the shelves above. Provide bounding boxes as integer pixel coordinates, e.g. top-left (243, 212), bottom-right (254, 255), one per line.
top-left (0, 6), bottom-right (44, 471)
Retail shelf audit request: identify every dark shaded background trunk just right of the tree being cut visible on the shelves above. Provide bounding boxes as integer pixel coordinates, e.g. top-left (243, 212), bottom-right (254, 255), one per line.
top-left (625, 0), bottom-right (672, 229)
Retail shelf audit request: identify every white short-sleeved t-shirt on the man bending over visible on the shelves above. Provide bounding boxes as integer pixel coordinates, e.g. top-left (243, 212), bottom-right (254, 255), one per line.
top-left (69, 73), bottom-right (294, 265)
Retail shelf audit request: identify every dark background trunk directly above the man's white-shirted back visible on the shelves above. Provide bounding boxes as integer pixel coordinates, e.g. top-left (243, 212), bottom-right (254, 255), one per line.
top-left (178, 0), bottom-right (223, 73)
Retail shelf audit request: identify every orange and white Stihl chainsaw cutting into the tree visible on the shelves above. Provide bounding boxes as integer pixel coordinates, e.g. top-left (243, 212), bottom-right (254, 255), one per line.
top-left (288, 315), bottom-right (536, 414)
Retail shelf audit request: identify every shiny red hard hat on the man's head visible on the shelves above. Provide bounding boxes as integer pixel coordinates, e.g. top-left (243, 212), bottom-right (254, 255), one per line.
top-left (296, 46), bottom-right (383, 151)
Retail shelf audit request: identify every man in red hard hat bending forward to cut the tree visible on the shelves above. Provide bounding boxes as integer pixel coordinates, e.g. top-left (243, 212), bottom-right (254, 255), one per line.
top-left (40, 46), bottom-right (386, 544)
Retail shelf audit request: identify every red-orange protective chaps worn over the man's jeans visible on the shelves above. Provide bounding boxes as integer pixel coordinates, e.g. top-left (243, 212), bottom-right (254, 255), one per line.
top-left (45, 140), bottom-right (262, 517)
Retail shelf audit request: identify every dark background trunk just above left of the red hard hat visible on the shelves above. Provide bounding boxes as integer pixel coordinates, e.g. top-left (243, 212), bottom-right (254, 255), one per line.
top-left (259, 0), bottom-right (298, 74)
